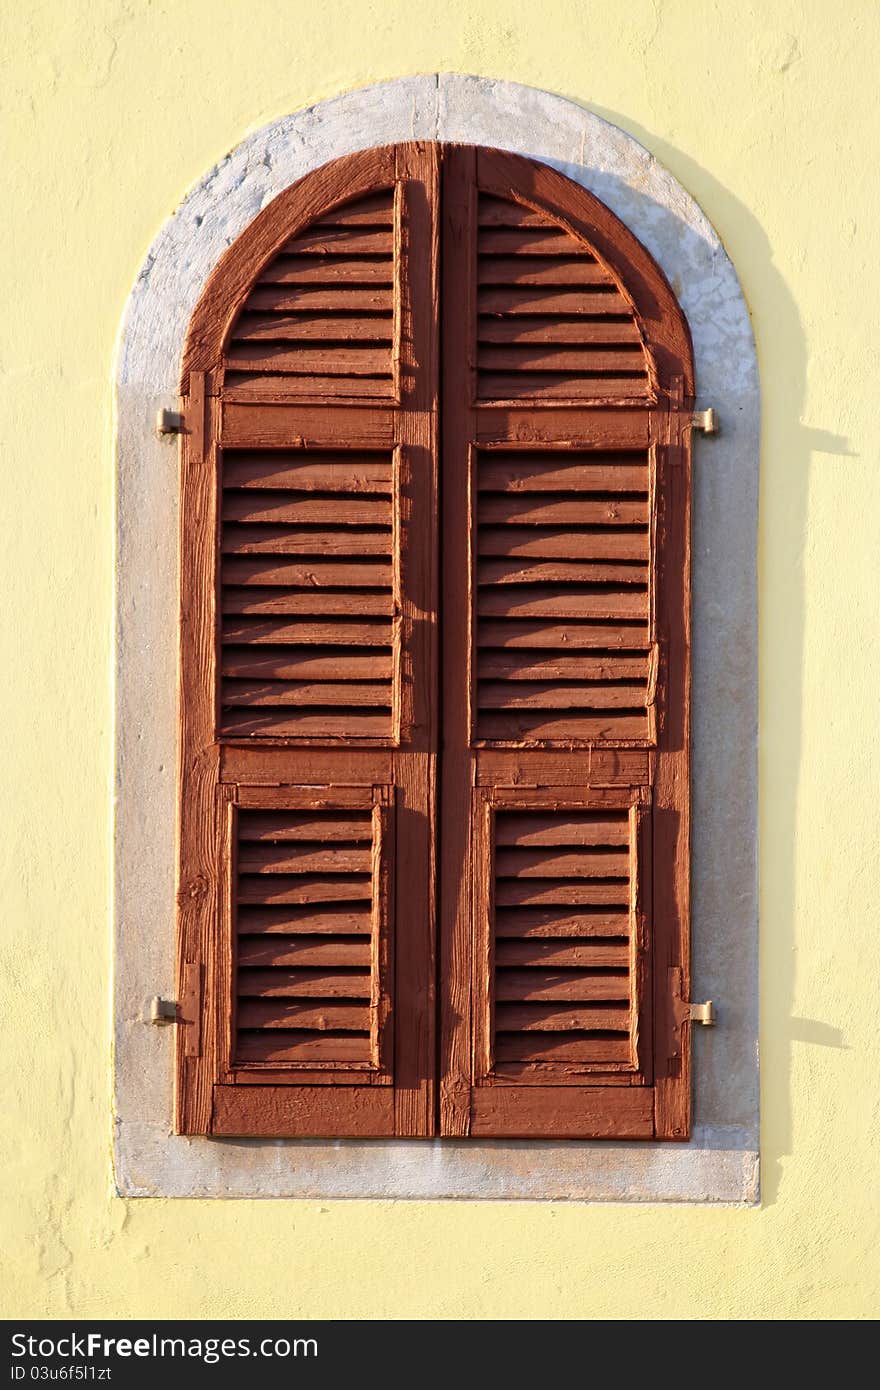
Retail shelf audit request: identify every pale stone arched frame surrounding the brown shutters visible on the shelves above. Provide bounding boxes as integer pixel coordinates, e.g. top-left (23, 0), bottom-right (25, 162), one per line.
top-left (115, 75), bottom-right (759, 1204)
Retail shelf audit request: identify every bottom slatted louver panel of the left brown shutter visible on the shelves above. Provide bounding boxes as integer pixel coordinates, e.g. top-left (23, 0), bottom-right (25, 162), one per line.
top-left (232, 806), bottom-right (382, 1069)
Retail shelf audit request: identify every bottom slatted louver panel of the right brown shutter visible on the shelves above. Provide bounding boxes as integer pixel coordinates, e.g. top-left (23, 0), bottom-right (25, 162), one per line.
top-left (492, 808), bottom-right (635, 1076)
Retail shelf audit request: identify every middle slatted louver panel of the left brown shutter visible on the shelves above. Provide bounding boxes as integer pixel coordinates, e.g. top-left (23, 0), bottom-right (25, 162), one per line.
top-left (220, 450), bottom-right (395, 741)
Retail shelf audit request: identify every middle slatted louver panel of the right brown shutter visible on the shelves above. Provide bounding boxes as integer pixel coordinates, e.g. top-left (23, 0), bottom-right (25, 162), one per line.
top-left (474, 450), bottom-right (651, 744)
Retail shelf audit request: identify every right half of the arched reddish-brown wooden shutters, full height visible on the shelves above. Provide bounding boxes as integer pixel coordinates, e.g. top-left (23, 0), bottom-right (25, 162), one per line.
top-left (441, 149), bottom-right (692, 1138)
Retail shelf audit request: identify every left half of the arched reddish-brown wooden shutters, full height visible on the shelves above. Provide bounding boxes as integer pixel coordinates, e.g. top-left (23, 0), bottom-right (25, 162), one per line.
top-left (177, 146), bottom-right (438, 1137)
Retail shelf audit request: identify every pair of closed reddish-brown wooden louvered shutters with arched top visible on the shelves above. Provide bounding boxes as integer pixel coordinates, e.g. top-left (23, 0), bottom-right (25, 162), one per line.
top-left (177, 143), bottom-right (694, 1138)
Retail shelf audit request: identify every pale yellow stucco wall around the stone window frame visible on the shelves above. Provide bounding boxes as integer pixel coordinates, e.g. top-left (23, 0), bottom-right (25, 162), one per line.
top-left (0, 0), bottom-right (880, 1318)
